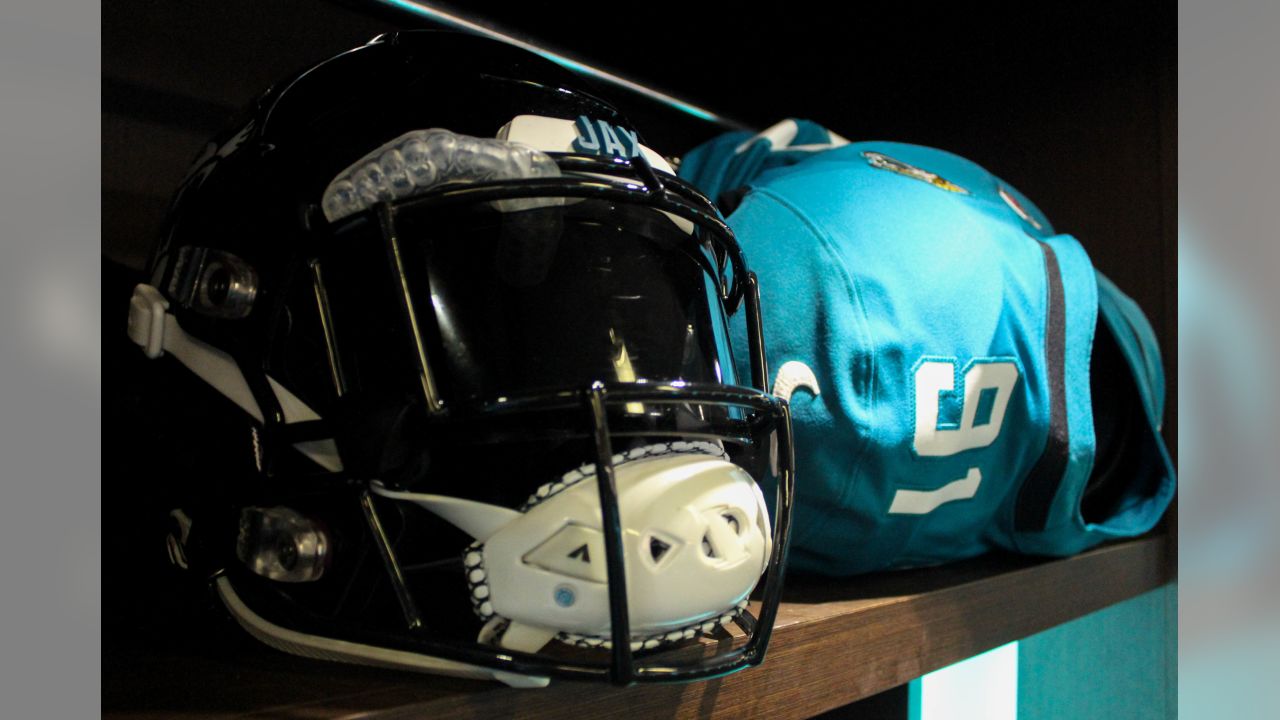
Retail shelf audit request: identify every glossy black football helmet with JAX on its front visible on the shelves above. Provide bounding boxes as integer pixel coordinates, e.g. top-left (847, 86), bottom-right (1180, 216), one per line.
top-left (129, 32), bottom-right (792, 685)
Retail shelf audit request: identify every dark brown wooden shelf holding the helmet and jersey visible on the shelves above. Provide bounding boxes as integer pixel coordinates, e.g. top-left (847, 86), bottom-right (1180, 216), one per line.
top-left (102, 534), bottom-right (1172, 720)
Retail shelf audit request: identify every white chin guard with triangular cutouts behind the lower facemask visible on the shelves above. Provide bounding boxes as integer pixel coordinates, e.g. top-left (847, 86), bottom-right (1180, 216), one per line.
top-left (374, 442), bottom-right (772, 652)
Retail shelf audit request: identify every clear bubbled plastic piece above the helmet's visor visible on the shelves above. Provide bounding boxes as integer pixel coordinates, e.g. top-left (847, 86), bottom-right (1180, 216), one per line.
top-left (321, 128), bottom-right (564, 222)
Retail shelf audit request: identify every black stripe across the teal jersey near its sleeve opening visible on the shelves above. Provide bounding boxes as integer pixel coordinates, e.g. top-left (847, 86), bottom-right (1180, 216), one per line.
top-left (1014, 242), bottom-right (1070, 533)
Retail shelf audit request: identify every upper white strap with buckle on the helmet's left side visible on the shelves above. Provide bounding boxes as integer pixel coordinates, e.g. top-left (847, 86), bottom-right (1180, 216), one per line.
top-left (129, 283), bottom-right (342, 473)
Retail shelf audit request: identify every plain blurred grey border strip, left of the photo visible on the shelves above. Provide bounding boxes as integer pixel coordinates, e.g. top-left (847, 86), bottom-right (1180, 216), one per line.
top-left (0, 1), bottom-right (101, 717)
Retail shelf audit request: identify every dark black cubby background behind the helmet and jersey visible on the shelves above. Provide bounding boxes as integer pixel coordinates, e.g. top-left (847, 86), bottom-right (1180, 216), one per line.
top-left (102, 0), bottom-right (1178, 630)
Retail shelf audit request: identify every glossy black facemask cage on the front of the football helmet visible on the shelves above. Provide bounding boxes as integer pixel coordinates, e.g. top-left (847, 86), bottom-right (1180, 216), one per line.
top-left (222, 156), bottom-right (792, 684)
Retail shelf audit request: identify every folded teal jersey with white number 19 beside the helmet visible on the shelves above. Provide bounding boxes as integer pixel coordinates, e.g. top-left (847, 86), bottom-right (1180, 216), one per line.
top-left (680, 120), bottom-right (1174, 575)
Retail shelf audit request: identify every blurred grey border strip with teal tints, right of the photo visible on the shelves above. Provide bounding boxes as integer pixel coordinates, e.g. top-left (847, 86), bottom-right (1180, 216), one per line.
top-left (1176, 0), bottom-right (1280, 717)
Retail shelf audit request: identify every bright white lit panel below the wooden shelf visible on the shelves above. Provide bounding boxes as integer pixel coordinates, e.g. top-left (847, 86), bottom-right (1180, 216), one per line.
top-left (908, 643), bottom-right (1018, 720)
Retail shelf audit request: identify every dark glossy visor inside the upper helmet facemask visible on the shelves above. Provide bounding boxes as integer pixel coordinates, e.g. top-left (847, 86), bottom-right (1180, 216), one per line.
top-left (321, 197), bottom-right (739, 406)
